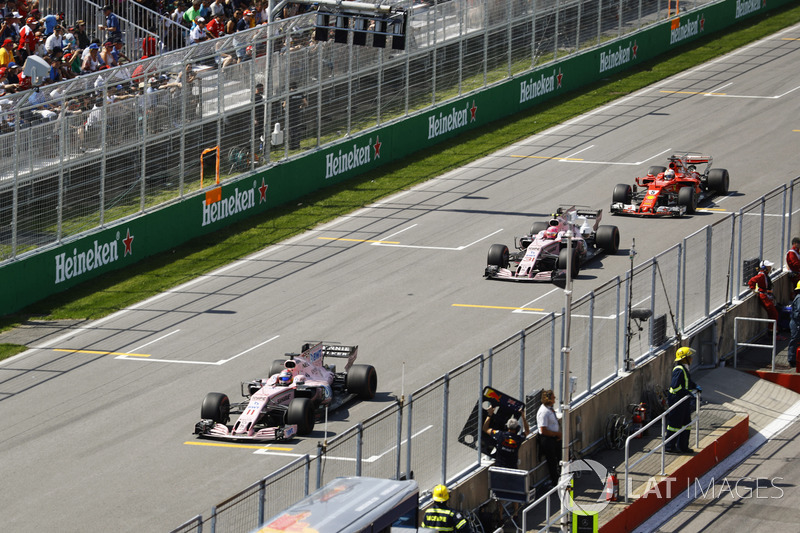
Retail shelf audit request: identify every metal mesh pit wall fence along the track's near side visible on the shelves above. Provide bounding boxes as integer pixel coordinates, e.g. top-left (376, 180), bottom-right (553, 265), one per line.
top-left (175, 177), bottom-right (800, 533)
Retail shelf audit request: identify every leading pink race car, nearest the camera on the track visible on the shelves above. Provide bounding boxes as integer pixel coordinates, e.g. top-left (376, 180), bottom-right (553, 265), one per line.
top-left (194, 342), bottom-right (378, 441)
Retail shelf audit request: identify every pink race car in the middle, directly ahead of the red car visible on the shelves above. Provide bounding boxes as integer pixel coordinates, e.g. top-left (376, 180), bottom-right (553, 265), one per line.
top-left (484, 206), bottom-right (619, 281)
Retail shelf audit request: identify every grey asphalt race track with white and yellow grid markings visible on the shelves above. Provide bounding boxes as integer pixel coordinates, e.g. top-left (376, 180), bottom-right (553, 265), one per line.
top-left (0, 26), bottom-right (800, 532)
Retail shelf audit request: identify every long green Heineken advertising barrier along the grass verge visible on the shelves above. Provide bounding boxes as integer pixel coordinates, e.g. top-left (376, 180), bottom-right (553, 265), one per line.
top-left (0, 0), bottom-right (795, 314)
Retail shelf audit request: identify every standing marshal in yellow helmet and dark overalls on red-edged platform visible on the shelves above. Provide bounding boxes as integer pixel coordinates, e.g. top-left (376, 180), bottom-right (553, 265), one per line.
top-left (666, 346), bottom-right (700, 453)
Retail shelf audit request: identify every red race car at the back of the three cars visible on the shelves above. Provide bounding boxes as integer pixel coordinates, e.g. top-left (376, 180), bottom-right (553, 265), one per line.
top-left (611, 152), bottom-right (730, 217)
